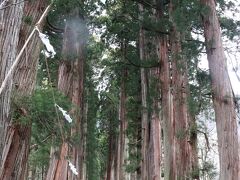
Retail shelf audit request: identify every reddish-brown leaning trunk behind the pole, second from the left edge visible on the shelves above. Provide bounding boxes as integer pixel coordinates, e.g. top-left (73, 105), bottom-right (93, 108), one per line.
top-left (0, 0), bottom-right (46, 180)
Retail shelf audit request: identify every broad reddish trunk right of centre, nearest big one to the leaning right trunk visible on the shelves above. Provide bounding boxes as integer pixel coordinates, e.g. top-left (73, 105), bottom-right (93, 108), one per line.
top-left (172, 31), bottom-right (192, 180)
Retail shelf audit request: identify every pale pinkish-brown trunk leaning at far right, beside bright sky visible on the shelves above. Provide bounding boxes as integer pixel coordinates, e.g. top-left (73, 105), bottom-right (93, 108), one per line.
top-left (201, 0), bottom-right (240, 180)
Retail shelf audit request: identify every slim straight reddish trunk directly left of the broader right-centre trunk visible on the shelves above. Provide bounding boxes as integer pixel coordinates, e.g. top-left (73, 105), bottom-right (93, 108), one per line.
top-left (156, 0), bottom-right (176, 180)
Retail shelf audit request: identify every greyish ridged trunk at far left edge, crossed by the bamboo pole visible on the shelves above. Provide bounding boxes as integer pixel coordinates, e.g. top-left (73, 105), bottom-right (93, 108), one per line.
top-left (0, 0), bottom-right (24, 165)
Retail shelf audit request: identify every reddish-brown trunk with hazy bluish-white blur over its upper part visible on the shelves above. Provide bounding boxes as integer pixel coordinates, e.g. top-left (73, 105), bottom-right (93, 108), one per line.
top-left (47, 11), bottom-right (86, 180)
